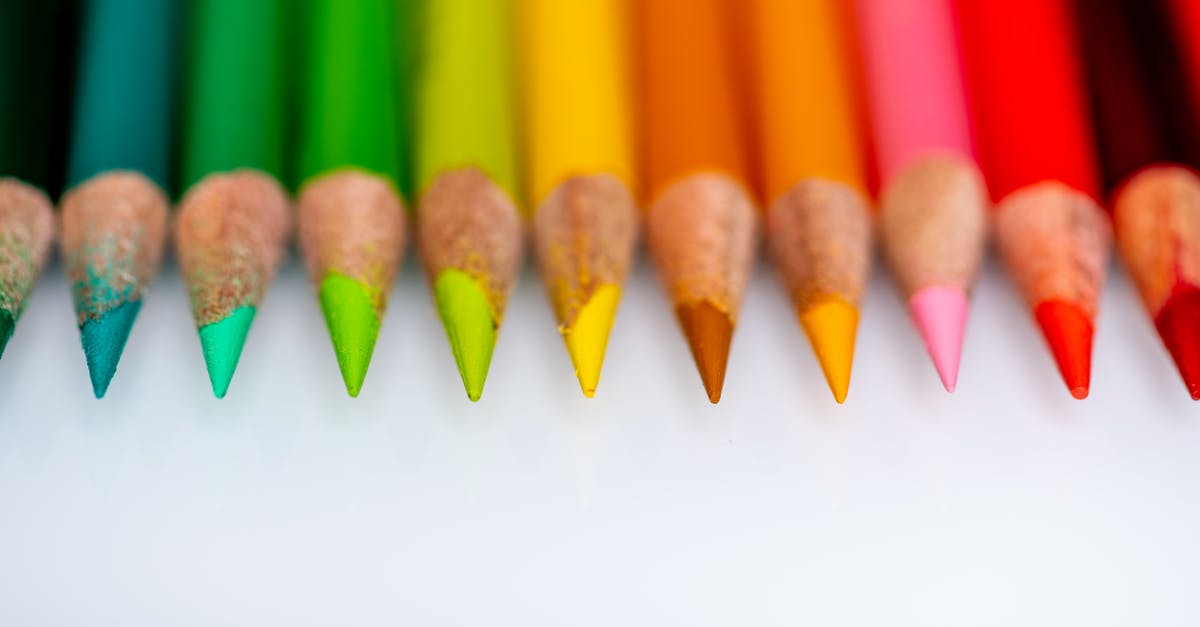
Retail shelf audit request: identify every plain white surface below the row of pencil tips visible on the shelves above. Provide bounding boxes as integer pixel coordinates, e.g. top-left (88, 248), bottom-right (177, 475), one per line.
top-left (0, 246), bottom-right (1200, 627)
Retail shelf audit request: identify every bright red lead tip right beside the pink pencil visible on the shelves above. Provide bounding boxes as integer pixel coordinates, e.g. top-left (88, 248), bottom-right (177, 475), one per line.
top-left (1033, 300), bottom-right (1094, 399)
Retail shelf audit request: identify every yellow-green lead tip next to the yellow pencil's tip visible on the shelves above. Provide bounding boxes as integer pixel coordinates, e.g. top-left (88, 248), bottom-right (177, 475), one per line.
top-left (433, 270), bottom-right (496, 401)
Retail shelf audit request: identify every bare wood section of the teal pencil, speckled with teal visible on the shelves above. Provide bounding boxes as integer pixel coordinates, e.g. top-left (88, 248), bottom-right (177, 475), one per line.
top-left (60, 171), bottom-right (170, 324)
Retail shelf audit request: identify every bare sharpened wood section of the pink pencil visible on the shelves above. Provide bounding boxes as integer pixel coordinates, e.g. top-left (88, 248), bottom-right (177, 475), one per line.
top-left (880, 153), bottom-right (988, 298)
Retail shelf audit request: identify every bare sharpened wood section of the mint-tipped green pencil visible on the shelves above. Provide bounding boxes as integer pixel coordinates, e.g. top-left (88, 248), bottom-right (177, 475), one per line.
top-left (175, 169), bottom-right (290, 327)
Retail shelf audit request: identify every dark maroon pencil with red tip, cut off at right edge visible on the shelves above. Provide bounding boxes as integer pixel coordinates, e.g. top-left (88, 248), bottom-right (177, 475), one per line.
top-left (1078, 0), bottom-right (1200, 400)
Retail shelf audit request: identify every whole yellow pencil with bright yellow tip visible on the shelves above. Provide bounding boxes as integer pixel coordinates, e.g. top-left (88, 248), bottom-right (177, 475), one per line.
top-left (521, 0), bottom-right (637, 398)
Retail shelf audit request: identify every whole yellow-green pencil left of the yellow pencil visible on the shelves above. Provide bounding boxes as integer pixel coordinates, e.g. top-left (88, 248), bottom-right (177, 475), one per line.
top-left (414, 0), bottom-right (522, 401)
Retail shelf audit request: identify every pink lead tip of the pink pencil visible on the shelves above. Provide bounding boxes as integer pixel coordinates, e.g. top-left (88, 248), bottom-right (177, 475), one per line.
top-left (908, 286), bottom-right (967, 393)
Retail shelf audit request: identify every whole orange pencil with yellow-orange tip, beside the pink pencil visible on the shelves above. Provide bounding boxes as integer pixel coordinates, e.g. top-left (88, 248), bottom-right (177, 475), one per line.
top-left (750, 0), bottom-right (871, 402)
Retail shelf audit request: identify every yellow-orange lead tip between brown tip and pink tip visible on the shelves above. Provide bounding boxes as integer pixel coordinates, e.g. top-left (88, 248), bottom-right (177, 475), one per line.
top-left (800, 298), bottom-right (858, 405)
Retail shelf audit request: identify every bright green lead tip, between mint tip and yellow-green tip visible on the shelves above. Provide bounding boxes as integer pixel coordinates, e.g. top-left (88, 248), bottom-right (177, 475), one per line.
top-left (317, 273), bottom-right (379, 396)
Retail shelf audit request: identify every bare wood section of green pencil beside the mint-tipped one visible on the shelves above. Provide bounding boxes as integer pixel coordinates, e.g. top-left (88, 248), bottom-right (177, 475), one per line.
top-left (296, 169), bottom-right (407, 301)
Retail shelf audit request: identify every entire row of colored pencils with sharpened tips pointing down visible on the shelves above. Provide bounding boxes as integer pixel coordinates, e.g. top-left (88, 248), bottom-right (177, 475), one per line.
top-left (0, 0), bottom-right (1200, 402)
